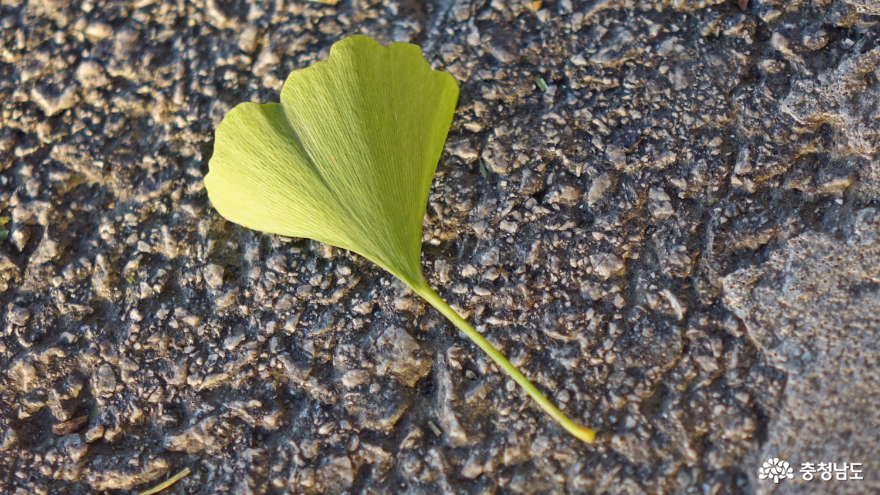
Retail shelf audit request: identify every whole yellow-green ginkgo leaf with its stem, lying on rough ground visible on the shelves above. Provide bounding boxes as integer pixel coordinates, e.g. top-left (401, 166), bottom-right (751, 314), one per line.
top-left (205, 36), bottom-right (595, 442)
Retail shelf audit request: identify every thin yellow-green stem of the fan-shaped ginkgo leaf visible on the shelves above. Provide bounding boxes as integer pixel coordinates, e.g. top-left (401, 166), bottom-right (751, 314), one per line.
top-left (410, 282), bottom-right (596, 443)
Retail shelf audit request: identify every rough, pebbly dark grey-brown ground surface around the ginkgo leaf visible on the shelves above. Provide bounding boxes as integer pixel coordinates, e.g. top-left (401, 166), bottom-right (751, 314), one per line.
top-left (0, 0), bottom-right (880, 494)
